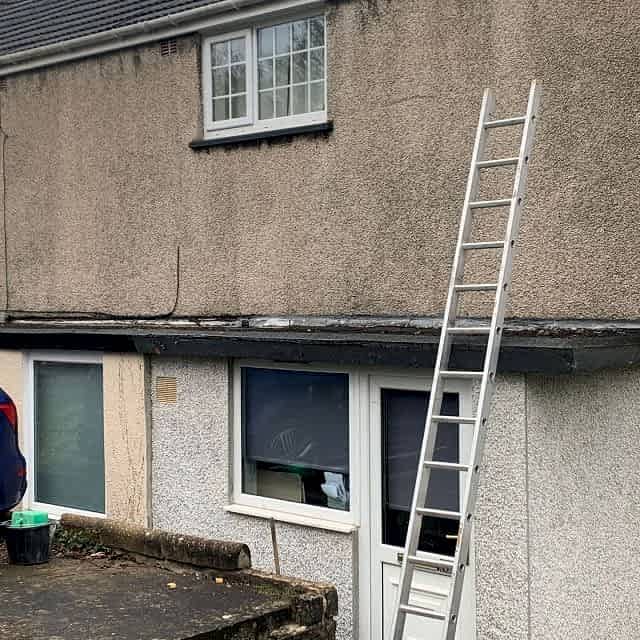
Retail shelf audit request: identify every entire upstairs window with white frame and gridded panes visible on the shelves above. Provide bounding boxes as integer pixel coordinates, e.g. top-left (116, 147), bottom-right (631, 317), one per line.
top-left (202, 16), bottom-right (327, 138)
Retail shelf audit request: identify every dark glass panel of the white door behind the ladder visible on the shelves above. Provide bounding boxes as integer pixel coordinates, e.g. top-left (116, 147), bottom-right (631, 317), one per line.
top-left (382, 389), bottom-right (460, 555)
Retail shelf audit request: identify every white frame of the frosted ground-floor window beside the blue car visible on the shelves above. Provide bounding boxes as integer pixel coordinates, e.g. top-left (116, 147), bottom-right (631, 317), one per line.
top-left (23, 351), bottom-right (107, 519)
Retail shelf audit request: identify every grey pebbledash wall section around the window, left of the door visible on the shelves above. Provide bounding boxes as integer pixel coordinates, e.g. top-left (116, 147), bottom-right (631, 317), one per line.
top-left (152, 358), bottom-right (354, 640)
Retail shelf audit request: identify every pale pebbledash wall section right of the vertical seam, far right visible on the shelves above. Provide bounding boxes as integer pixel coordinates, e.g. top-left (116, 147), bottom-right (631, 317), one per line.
top-left (527, 368), bottom-right (640, 640)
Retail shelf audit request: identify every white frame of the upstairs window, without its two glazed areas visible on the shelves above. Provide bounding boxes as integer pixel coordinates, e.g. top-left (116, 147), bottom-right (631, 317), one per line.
top-left (201, 11), bottom-right (328, 139)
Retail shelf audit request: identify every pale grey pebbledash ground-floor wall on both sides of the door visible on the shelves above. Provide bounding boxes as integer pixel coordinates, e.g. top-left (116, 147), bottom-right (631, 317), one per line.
top-left (151, 357), bottom-right (640, 640)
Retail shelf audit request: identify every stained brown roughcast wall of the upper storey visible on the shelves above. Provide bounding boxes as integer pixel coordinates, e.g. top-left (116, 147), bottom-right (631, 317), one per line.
top-left (0, 0), bottom-right (640, 318)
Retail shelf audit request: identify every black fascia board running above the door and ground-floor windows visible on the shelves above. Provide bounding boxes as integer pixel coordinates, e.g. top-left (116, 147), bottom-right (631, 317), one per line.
top-left (0, 323), bottom-right (640, 375)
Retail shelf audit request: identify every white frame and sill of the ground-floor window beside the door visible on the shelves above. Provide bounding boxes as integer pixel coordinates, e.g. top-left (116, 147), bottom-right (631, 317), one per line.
top-left (228, 360), bottom-right (361, 531)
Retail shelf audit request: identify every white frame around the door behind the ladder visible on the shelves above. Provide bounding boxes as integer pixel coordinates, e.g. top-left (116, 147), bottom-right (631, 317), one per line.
top-left (356, 372), bottom-right (475, 640)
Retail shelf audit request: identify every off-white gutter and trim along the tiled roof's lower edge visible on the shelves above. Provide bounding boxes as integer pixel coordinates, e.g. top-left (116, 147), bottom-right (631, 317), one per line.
top-left (0, 0), bottom-right (326, 77)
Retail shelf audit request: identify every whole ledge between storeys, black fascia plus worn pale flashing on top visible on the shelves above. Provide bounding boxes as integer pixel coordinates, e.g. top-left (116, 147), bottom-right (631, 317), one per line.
top-left (0, 318), bottom-right (640, 375)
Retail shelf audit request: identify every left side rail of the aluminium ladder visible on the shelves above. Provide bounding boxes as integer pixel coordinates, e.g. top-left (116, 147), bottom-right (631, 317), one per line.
top-left (391, 89), bottom-right (495, 640)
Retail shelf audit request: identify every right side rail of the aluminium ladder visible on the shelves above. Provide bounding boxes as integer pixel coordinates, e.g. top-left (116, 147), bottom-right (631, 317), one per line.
top-left (445, 80), bottom-right (540, 640)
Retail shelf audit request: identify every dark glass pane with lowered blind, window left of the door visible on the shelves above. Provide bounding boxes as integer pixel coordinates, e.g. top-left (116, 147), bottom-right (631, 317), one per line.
top-left (242, 368), bottom-right (349, 510)
